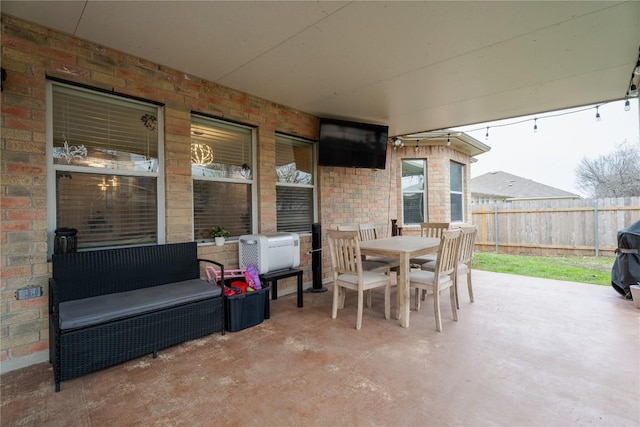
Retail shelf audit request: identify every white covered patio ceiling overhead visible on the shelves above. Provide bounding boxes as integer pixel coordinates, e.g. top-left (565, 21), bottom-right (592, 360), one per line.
top-left (5, 0), bottom-right (640, 135)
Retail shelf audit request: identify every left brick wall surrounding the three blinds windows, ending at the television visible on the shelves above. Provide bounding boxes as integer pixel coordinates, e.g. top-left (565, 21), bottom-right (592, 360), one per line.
top-left (0, 15), bottom-right (318, 371)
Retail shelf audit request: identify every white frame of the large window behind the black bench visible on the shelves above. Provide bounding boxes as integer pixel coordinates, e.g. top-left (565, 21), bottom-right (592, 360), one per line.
top-left (45, 79), bottom-right (166, 259)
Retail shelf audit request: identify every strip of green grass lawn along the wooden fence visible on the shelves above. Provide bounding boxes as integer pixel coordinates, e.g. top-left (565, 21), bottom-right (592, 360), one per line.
top-left (473, 252), bottom-right (615, 286)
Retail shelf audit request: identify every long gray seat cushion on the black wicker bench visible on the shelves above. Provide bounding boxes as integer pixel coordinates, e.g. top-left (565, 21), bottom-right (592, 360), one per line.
top-left (59, 279), bottom-right (222, 330)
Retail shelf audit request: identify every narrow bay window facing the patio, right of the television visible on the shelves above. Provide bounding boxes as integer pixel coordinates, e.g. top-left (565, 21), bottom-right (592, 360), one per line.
top-left (402, 160), bottom-right (427, 225)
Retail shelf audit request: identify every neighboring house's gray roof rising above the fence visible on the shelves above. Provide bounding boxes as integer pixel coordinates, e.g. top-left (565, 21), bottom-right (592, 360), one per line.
top-left (471, 171), bottom-right (581, 199)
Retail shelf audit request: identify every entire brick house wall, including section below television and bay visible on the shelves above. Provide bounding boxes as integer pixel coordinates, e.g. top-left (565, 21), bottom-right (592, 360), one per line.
top-left (0, 15), bottom-right (468, 371)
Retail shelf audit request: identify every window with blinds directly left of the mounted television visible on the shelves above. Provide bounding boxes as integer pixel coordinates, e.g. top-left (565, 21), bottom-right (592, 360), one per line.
top-left (276, 134), bottom-right (315, 233)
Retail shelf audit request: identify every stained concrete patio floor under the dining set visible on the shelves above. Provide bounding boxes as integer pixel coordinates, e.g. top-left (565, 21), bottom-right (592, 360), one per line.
top-left (0, 271), bottom-right (640, 427)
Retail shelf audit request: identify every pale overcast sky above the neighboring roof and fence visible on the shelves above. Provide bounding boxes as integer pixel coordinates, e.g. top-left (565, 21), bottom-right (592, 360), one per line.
top-left (456, 98), bottom-right (640, 197)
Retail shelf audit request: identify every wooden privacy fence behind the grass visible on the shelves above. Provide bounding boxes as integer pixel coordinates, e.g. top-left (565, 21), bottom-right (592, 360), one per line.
top-left (472, 197), bottom-right (640, 256)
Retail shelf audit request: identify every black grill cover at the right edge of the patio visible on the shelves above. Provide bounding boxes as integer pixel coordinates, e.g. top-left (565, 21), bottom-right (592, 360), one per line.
top-left (611, 221), bottom-right (640, 299)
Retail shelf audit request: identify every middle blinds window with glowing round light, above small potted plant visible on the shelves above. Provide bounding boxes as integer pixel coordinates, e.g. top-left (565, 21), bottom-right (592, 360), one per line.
top-left (191, 115), bottom-right (255, 239)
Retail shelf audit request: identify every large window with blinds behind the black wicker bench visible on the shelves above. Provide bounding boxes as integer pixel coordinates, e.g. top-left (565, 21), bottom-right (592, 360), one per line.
top-left (48, 82), bottom-right (164, 252)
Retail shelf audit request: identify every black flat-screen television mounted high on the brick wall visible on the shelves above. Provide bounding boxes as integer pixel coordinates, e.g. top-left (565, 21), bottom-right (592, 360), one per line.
top-left (318, 119), bottom-right (389, 169)
